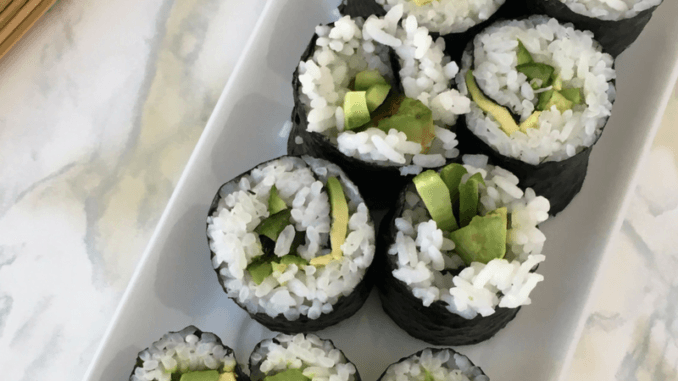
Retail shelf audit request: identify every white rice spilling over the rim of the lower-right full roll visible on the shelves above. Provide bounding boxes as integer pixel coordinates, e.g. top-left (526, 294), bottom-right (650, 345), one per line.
top-left (388, 155), bottom-right (550, 319)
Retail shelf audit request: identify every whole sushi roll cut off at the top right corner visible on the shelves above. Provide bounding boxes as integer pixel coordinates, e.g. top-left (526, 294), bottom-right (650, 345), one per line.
top-left (525, 0), bottom-right (663, 57)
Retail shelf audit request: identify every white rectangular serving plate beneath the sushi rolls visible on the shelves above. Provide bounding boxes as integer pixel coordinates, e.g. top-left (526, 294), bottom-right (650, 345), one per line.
top-left (85, 0), bottom-right (678, 381)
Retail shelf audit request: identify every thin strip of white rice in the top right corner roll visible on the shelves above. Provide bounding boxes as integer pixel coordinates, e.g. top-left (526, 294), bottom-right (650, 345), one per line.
top-left (560, 0), bottom-right (663, 20)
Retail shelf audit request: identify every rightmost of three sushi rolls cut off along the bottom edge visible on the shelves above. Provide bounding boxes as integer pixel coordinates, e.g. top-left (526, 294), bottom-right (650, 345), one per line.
top-left (377, 348), bottom-right (490, 381)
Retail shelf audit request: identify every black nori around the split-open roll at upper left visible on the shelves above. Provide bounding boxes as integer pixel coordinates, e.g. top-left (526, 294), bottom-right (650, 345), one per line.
top-left (287, 21), bottom-right (461, 210)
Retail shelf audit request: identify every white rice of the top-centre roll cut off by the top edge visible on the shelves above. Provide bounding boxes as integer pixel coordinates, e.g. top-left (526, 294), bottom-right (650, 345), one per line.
top-left (376, 0), bottom-right (506, 34)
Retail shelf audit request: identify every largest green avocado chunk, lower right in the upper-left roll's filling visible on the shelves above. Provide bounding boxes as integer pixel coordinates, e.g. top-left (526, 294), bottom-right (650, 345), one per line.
top-left (377, 98), bottom-right (436, 153)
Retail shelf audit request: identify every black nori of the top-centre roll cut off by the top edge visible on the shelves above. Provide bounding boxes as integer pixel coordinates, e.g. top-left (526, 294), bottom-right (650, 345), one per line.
top-left (339, 0), bottom-right (526, 64)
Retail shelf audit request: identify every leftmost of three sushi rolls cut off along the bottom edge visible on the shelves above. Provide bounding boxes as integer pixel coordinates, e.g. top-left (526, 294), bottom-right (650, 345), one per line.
top-left (129, 325), bottom-right (249, 381)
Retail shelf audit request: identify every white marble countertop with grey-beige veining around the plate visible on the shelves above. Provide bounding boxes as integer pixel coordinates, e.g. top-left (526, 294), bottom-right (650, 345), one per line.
top-left (0, 0), bottom-right (678, 381)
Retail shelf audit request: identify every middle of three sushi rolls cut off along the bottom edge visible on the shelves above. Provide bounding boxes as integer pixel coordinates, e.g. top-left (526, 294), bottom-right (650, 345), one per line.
top-left (250, 333), bottom-right (360, 381)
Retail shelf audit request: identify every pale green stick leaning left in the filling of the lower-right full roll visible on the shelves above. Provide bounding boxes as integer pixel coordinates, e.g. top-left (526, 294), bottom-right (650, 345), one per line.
top-left (412, 170), bottom-right (458, 231)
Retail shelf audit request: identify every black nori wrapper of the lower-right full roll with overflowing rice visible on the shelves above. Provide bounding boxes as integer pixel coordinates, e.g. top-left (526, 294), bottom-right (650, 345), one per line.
top-left (375, 189), bottom-right (520, 345)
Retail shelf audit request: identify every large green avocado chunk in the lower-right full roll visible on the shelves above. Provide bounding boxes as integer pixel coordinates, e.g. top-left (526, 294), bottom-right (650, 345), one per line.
top-left (450, 208), bottom-right (507, 265)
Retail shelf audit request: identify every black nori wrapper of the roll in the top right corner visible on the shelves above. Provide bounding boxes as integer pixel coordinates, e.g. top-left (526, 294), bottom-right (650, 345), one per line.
top-left (525, 0), bottom-right (658, 58)
